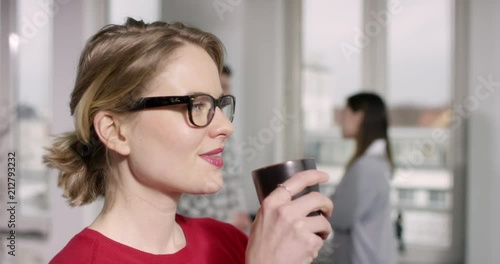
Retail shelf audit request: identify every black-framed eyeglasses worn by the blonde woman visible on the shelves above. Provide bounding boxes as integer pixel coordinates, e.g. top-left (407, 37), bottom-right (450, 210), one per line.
top-left (129, 94), bottom-right (236, 127)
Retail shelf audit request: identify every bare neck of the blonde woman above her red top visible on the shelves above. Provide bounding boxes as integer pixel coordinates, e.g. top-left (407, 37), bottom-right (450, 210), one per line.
top-left (89, 168), bottom-right (186, 254)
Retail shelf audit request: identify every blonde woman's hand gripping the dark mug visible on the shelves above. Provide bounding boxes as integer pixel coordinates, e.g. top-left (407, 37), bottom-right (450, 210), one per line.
top-left (247, 159), bottom-right (333, 264)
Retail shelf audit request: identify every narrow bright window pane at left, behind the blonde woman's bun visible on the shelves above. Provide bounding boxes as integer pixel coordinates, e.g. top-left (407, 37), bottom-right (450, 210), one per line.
top-left (16, 0), bottom-right (53, 222)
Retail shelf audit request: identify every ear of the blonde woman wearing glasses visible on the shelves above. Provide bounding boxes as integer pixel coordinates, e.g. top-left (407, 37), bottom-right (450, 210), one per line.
top-left (94, 111), bottom-right (130, 156)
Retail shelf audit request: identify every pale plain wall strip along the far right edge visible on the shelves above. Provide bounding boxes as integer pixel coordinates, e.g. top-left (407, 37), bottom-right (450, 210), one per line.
top-left (466, 0), bottom-right (500, 264)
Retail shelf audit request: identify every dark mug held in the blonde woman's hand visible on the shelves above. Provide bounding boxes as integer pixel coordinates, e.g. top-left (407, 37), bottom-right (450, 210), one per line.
top-left (252, 158), bottom-right (320, 216)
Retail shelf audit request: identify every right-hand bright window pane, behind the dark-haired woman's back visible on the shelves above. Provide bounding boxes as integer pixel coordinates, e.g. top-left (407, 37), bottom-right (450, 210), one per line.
top-left (386, 0), bottom-right (453, 253)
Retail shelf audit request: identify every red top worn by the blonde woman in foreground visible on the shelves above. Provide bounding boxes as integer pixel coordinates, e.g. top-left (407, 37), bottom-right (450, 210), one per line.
top-left (50, 215), bottom-right (248, 264)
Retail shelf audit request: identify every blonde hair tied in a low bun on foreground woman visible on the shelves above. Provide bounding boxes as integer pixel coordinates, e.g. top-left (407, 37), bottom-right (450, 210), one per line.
top-left (43, 18), bottom-right (224, 206)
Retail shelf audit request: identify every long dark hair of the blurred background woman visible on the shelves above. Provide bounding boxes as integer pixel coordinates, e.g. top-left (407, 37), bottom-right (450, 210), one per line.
top-left (347, 92), bottom-right (394, 168)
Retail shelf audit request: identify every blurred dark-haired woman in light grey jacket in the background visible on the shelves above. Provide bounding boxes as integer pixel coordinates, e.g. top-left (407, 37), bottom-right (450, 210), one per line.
top-left (330, 92), bottom-right (396, 264)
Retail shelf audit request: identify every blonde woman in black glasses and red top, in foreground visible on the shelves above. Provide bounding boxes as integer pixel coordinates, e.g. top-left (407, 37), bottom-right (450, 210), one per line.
top-left (44, 19), bottom-right (333, 264)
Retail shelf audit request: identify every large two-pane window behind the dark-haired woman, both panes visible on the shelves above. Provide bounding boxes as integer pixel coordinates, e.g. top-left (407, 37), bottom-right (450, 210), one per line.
top-left (301, 0), bottom-right (464, 263)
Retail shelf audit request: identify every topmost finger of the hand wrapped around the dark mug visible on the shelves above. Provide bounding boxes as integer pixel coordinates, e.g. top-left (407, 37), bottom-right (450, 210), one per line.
top-left (283, 192), bottom-right (333, 218)
